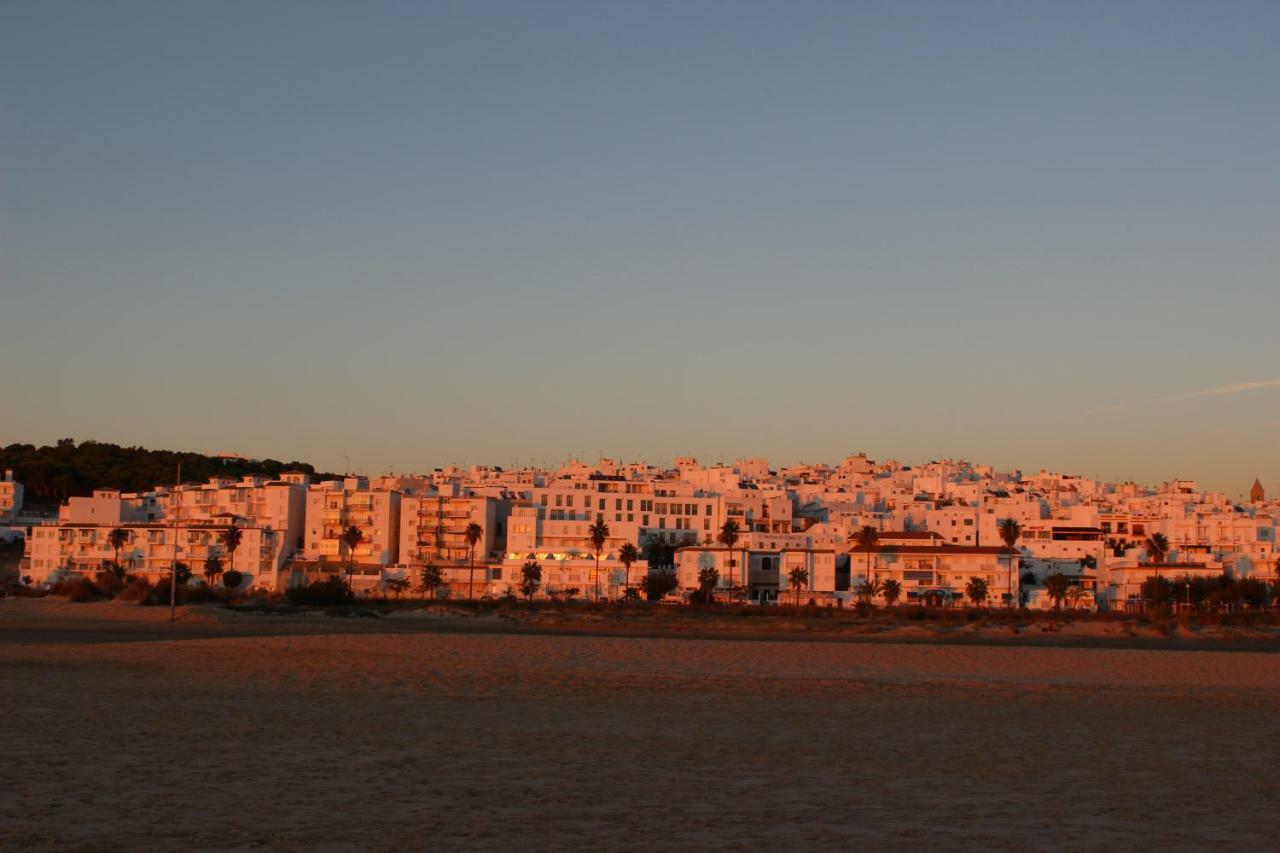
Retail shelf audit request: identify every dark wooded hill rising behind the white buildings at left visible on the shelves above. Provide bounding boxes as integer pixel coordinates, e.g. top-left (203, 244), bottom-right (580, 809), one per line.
top-left (0, 438), bottom-right (337, 502)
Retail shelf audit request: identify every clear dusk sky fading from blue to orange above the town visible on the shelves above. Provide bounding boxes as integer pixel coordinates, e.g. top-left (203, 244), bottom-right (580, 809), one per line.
top-left (0, 0), bottom-right (1280, 494)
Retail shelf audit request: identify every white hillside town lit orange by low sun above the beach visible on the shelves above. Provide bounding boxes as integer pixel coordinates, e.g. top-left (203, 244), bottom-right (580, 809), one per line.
top-left (0, 453), bottom-right (1280, 611)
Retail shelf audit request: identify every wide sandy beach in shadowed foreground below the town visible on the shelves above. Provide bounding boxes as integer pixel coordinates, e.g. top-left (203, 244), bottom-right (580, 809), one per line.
top-left (0, 601), bottom-right (1280, 850)
